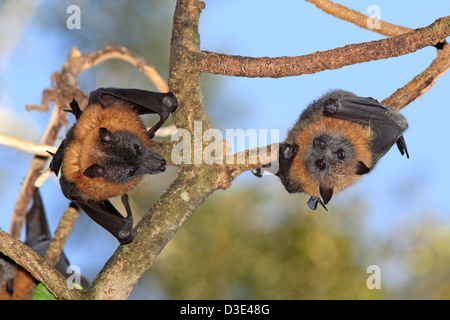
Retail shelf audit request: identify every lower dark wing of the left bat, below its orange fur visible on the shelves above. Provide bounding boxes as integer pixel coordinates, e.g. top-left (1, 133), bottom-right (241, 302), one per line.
top-left (59, 177), bottom-right (134, 244)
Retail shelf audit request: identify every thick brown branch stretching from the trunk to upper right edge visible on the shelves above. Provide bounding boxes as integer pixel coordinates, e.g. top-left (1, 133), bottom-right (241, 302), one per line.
top-left (191, 17), bottom-right (450, 78)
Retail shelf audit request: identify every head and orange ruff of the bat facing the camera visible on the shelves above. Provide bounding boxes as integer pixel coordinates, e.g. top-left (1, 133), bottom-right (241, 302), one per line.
top-left (288, 118), bottom-right (372, 208)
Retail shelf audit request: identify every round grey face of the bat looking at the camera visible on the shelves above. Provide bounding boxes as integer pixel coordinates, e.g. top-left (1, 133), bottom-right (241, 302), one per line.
top-left (305, 134), bottom-right (355, 179)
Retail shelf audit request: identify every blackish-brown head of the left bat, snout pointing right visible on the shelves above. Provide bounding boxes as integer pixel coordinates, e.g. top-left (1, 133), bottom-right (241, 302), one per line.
top-left (84, 128), bottom-right (166, 183)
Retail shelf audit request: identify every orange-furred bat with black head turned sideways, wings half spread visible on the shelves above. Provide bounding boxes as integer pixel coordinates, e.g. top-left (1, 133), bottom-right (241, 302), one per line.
top-left (50, 88), bottom-right (178, 244)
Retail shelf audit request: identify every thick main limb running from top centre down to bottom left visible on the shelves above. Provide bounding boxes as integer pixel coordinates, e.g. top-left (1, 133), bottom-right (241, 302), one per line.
top-left (87, 0), bottom-right (213, 299)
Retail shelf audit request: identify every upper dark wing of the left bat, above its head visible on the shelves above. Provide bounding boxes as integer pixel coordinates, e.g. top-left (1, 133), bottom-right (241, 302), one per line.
top-left (89, 88), bottom-right (178, 139)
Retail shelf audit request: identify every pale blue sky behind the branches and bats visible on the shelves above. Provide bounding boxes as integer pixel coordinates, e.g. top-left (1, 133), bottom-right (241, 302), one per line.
top-left (0, 0), bottom-right (450, 298)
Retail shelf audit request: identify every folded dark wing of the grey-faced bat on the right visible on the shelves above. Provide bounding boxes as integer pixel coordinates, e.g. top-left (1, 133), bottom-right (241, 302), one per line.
top-left (323, 96), bottom-right (409, 165)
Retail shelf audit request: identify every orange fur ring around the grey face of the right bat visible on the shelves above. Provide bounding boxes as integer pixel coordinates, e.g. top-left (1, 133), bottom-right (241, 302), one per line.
top-left (289, 117), bottom-right (373, 197)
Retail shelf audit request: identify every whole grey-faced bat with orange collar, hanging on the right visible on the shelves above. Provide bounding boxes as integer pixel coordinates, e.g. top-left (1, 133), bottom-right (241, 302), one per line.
top-left (254, 90), bottom-right (409, 210)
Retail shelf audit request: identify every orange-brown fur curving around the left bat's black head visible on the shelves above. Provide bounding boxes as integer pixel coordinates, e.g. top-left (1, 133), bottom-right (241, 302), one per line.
top-left (62, 104), bottom-right (149, 201)
